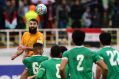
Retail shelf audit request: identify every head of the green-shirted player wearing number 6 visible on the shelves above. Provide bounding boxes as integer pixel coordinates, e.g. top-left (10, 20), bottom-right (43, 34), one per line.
top-left (33, 43), bottom-right (43, 55)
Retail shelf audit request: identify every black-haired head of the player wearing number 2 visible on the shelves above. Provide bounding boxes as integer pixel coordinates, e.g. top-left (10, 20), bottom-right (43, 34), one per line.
top-left (72, 30), bottom-right (85, 45)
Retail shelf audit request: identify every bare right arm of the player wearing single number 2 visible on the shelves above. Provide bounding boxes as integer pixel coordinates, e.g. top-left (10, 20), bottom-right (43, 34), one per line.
top-left (97, 60), bottom-right (108, 79)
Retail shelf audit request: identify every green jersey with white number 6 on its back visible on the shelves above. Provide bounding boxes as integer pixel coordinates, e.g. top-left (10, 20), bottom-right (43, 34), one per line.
top-left (23, 55), bottom-right (48, 76)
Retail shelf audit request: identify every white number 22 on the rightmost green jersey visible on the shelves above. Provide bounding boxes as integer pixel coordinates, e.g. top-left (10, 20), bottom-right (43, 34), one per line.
top-left (106, 50), bottom-right (119, 66)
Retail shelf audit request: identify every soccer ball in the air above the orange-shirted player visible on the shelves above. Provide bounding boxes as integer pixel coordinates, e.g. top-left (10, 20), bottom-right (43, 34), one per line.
top-left (36, 4), bottom-right (47, 15)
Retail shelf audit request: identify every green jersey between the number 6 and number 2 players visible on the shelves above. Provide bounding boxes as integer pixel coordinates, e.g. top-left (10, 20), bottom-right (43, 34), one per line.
top-left (36, 58), bottom-right (68, 79)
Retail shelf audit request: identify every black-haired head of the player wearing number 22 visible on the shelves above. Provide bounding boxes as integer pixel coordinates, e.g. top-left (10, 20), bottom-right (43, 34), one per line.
top-left (99, 32), bottom-right (111, 45)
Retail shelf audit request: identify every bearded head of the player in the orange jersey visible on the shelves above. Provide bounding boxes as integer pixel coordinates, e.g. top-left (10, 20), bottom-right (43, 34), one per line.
top-left (29, 19), bottom-right (38, 34)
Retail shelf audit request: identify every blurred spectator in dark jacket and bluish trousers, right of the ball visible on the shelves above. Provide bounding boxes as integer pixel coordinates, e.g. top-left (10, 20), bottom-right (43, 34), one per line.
top-left (56, 0), bottom-right (70, 28)
